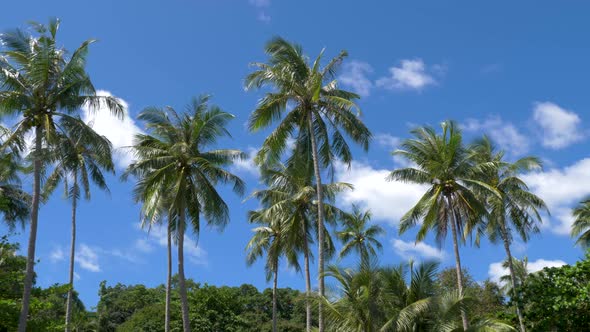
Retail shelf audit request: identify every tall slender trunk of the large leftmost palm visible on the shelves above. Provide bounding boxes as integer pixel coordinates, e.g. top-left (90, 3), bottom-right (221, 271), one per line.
top-left (18, 125), bottom-right (43, 332)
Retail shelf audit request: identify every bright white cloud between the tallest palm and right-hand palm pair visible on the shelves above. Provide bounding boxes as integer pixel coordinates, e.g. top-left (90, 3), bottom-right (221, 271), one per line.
top-left (335, 161), bottom-right (427, 225)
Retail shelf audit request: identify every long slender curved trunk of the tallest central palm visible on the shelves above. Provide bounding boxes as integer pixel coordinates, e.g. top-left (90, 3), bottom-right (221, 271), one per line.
top-left (307, 112), bottom-right (324, 332)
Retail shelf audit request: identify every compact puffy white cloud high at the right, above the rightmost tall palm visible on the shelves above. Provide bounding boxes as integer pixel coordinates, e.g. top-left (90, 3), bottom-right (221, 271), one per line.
top-left (533, 102), bottom-right (584, 149)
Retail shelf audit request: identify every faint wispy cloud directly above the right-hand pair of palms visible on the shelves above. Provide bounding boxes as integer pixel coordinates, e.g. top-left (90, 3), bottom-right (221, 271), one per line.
top-left (463, 116), bottom-right (531, 155)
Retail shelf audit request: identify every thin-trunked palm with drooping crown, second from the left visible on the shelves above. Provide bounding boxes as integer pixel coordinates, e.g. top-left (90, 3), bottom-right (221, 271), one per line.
top-left (43, 121), bottom-right (115, 332)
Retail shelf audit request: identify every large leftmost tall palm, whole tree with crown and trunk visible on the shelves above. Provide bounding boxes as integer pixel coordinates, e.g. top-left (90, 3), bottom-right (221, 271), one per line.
top-left (0, 19), bottom-right (123, 332)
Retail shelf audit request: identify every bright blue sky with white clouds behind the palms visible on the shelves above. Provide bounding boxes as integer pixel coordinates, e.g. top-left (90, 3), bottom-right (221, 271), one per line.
top-left (0, 0), bottom-right (590, 306)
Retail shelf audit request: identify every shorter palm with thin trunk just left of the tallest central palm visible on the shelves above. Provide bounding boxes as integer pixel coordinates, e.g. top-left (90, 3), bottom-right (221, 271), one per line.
top-left (246, 209), bottom-right (300, 332)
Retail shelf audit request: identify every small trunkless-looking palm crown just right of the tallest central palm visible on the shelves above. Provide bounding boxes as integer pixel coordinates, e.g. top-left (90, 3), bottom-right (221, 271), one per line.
top-left (336, 205), bottom-right (385, 261)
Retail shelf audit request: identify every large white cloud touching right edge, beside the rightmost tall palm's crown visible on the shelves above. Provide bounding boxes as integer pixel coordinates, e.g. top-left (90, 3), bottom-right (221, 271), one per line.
top-left (522, 158), bottom-right (590, 235)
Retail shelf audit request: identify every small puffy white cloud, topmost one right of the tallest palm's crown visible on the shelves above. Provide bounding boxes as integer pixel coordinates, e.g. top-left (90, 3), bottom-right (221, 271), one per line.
top-left (375, 59), bottom-right (436, 90)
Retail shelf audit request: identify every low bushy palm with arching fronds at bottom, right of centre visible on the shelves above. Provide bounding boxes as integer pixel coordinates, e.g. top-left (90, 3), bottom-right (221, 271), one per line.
top-left (321, 260), bottom-right (514, 332)
